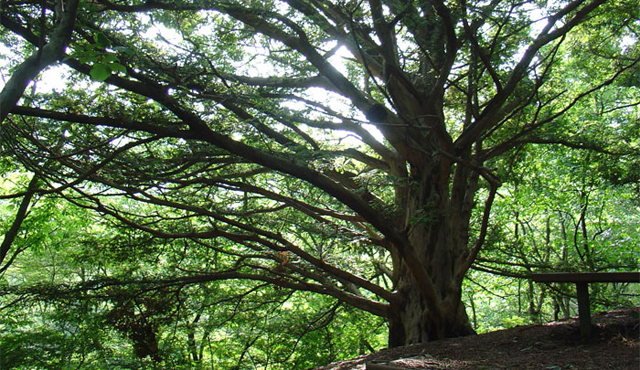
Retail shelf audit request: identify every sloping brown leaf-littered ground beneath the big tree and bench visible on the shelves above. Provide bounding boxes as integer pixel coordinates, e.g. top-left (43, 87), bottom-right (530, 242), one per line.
top-left (316, 308), bottom-right (640, 370)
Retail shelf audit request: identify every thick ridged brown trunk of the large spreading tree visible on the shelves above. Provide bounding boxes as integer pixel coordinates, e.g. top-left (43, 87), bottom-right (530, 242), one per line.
top-left (389, 162), bottom-right (476, 347)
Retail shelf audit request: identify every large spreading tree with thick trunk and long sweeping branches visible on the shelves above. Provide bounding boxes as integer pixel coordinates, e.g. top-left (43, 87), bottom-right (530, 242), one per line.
top-left (1, 0), bottom-right (640, 346)
